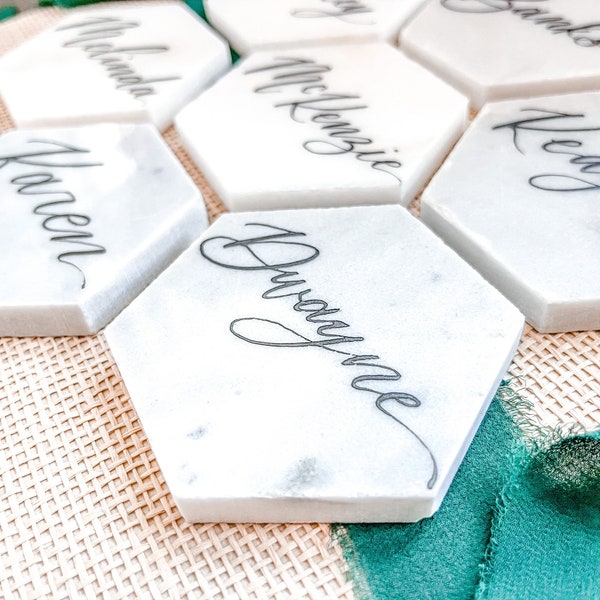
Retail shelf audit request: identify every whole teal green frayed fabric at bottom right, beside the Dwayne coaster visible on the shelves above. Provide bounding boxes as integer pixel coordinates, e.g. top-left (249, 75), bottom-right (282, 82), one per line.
top-left (335, 382), bottom-right (600, 600)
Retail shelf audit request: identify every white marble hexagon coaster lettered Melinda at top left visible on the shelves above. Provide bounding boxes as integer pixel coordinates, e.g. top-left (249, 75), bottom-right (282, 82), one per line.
top-left (0, 2), bottom-right (231, 129)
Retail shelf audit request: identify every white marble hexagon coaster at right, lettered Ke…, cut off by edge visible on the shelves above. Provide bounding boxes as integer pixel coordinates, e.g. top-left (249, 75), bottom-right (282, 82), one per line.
top-left (422, 93), bottom-right (600, 332)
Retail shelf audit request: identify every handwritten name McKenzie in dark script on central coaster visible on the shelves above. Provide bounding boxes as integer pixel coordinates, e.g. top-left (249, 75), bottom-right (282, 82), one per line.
top-left (244, 56), bottom-right (402, 188)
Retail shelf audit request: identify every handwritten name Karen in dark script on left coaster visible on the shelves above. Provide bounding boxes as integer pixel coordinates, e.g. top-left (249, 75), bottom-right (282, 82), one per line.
top-left (0, 140), bottom-right (106, 288)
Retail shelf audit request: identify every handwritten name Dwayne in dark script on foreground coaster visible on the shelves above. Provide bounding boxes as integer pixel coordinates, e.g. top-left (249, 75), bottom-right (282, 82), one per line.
top-left (199, 223), bottom-right (438, 489)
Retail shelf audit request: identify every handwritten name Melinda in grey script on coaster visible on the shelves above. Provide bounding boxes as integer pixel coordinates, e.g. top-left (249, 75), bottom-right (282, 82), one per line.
top-left (56, 17), bottom-right (181, 99)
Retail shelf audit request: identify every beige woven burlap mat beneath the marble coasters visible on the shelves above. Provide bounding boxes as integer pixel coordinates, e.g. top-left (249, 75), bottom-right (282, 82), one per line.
top-left (0, 9), bottom-right (600, 599)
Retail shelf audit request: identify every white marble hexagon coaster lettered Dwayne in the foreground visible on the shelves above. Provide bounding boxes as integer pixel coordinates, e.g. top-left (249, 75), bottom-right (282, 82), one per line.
top-left (105, 206), bottom-right (523, 522)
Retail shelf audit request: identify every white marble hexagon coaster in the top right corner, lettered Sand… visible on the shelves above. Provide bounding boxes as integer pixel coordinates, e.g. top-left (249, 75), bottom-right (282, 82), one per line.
top-left (400, 0), bottom-right (600, 108)
